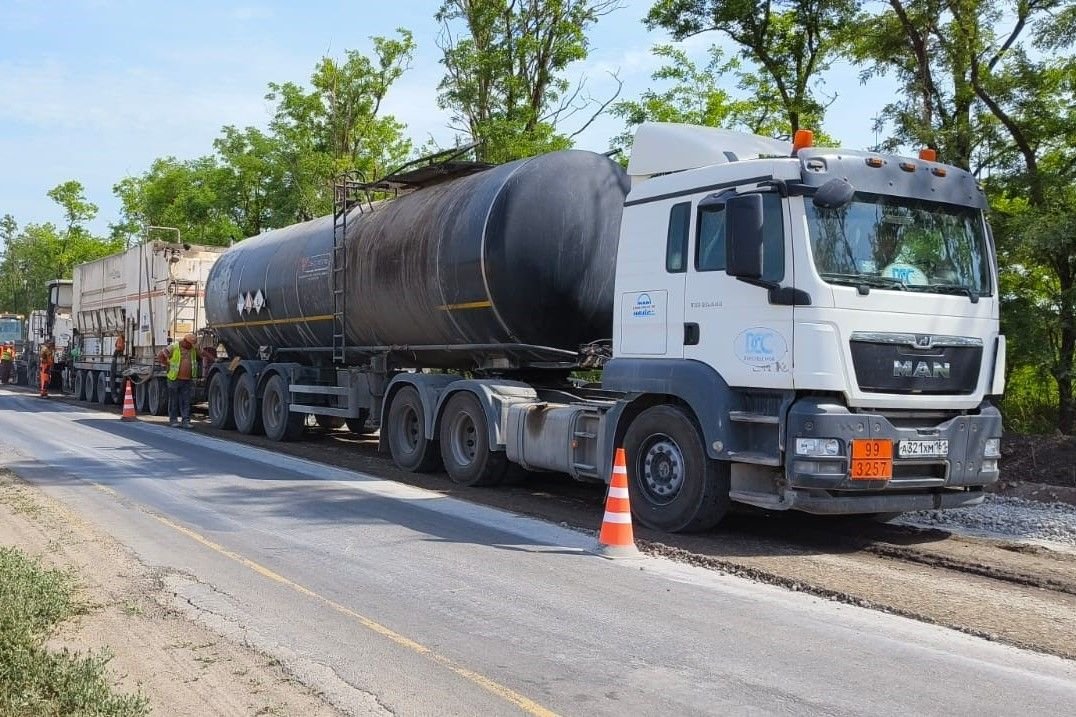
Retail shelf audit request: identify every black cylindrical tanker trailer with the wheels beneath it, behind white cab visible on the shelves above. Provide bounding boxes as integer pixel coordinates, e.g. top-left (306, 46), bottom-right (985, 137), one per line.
top-left (206, 151), bottom-right (629, 484)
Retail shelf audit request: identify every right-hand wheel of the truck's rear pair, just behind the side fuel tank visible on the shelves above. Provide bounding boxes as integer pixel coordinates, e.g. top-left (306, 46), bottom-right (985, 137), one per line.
top-left (440, 391), bottom-right (508, 486)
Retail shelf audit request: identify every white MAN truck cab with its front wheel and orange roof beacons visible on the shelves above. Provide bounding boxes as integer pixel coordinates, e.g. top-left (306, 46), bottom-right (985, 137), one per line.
top-left (603, 124), bottom-right (1005, 530)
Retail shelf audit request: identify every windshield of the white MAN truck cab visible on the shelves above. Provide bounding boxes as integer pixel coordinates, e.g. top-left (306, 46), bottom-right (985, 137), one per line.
top-left (805, 193), bottom-right (991, 297)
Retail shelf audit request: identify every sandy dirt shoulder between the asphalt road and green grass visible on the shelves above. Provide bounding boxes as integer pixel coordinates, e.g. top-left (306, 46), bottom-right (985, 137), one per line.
top-left (0, 470), bottom-right (340, 717)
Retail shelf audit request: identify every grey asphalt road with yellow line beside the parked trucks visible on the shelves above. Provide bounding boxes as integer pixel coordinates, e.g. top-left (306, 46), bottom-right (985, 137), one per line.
top-left (0, 390), bottom-right (1076, 715)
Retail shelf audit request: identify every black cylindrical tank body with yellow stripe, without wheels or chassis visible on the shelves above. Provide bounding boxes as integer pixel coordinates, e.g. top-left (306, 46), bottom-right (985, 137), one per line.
top-left (206, 151), bottom-right (628, 368)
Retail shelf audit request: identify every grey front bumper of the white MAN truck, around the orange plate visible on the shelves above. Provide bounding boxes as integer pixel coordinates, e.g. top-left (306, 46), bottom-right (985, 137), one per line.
top-left (784, 398), bottom-right (1002, 514)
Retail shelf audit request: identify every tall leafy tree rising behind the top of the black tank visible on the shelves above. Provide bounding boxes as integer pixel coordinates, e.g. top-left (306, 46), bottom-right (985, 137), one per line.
top-left (436, 0), bottom-right (621, 163)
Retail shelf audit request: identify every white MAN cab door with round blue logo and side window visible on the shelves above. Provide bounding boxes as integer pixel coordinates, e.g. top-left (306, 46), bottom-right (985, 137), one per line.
top-left (684, 185), bottom-right (795, 389)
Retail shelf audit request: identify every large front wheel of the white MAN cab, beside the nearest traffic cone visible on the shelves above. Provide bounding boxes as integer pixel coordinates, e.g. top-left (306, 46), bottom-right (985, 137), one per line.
top-left (624, 406), bottom-right (732, 533)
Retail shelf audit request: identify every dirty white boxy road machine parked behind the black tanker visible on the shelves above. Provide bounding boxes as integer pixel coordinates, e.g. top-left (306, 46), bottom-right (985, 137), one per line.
top-left (71, 241), bottom-right (224, 416)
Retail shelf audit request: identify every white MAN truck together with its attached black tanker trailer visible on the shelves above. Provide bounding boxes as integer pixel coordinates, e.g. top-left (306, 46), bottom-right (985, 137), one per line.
top-left (197, 124), bottom-right (1005, 531)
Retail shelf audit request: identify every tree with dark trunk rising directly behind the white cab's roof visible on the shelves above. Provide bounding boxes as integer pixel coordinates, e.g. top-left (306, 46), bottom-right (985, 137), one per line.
top-left (646, 0), bottom-right (855, 135)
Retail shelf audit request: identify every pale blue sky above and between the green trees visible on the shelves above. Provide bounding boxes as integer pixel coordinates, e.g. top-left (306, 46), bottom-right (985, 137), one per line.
top-left (0, 0), bottom-right (893, 234)
